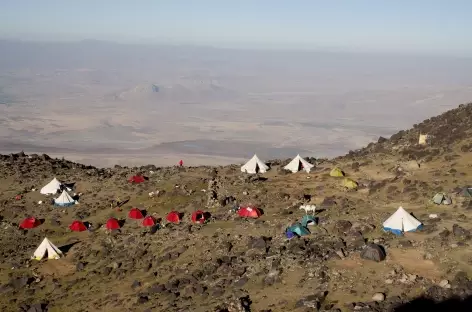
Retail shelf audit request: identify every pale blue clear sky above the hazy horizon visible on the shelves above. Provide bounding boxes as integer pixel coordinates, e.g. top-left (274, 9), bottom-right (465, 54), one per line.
top-left (0, 0), bottom-right (472, 56)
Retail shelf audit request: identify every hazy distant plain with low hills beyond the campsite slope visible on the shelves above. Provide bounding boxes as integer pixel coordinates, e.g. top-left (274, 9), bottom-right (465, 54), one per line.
top-left (0, 40), bottom-right (472, 166)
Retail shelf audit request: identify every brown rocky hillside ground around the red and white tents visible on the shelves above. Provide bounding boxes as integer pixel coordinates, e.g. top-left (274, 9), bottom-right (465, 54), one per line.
top-left (0, 104), bottom-right (472, 312)
